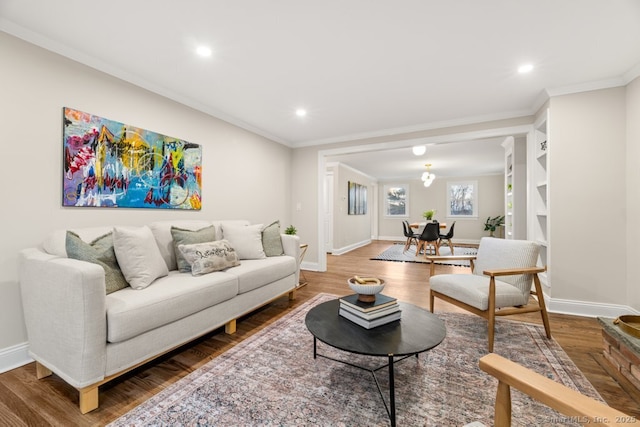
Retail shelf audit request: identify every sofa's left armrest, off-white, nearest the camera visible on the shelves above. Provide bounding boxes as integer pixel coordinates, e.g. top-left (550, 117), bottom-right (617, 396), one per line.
top-left (18, 248), bottom-right (107, 388)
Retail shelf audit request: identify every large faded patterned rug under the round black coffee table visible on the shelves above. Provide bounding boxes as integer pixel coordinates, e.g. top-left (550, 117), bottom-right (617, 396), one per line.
top-left (110, 294), bottom-right (601, 426)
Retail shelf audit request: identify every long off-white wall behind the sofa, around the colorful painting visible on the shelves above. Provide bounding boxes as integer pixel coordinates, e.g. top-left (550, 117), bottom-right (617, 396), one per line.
top-left (0, 32), bottom-right (291, 370)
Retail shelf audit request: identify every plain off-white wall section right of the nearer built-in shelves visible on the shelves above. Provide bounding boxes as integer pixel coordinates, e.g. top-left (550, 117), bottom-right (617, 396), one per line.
top-left (549, 87), bottom-right (628, 305)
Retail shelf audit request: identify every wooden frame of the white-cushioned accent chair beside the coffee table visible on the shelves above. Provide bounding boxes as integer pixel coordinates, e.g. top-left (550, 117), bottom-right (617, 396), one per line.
top-left (427, 255), bottom-right (551, 353)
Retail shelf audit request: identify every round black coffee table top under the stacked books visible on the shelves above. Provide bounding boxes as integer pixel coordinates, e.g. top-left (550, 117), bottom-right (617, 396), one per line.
top-left (305, 299), bottom-right (446, 356)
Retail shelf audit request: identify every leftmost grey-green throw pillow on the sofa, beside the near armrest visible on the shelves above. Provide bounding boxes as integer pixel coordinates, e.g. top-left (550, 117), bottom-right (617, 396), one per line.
top-left (65, 231), bottom-right (129, 294)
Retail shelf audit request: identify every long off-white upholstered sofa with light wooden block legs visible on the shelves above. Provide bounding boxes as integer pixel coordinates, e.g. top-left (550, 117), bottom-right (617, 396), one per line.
top-left (19, 220), bottom-right (300, 413)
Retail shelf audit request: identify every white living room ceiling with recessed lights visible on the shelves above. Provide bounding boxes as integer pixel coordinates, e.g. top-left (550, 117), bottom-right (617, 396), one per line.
top-left (0, 0), bottom-right (640, 179)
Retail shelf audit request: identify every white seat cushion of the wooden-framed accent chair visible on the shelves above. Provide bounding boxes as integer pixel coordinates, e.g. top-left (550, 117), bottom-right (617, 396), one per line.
top-left (429, 274), bottom-right (529, 310)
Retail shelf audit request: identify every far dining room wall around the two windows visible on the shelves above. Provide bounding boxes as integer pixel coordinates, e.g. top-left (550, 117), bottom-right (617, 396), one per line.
top-left (379, 174), bottom-right (504, 242)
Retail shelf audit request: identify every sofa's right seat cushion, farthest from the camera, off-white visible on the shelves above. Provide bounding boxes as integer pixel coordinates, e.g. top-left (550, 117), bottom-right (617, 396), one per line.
top-left (225, 255), bottom-right (298, 294)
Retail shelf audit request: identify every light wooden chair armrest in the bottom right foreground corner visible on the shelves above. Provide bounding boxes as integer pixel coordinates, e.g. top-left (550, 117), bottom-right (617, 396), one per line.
top-left (479, 353), bottom-right (635, 426)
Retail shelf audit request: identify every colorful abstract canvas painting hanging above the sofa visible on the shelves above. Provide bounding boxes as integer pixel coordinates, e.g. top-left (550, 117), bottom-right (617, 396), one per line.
top-left (62, 108), bottom-right (202, 210)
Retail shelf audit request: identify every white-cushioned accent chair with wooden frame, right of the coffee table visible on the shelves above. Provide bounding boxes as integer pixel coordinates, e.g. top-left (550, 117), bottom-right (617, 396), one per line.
top-left (427, 237), bottom-right (551, 352)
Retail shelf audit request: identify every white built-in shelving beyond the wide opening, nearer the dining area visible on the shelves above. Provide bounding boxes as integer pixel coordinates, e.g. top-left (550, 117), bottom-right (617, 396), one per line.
top-left (502, 136), bottom-right (527, 239)
